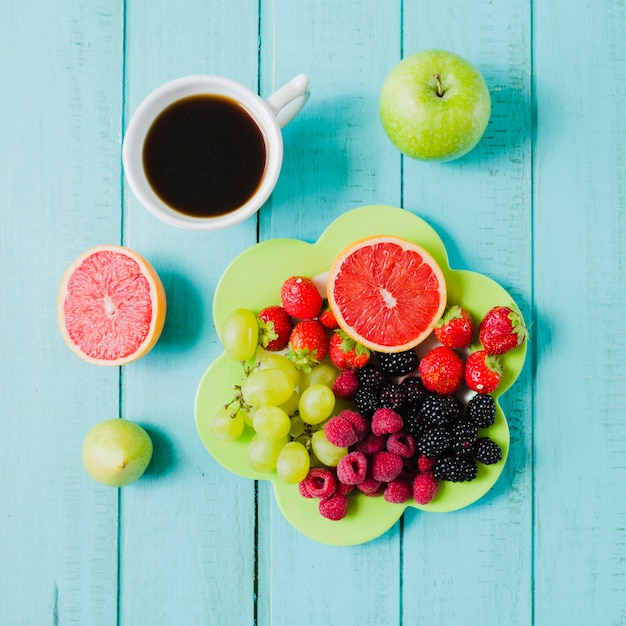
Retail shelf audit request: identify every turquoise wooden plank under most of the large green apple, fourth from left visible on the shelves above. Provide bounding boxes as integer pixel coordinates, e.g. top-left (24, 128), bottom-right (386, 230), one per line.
top-left (403, 1), bottom-right (533, 624)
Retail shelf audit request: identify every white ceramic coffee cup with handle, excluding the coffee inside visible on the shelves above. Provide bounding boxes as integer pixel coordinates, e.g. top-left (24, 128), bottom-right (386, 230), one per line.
top-left (122, 74), bottom-right (309, 231)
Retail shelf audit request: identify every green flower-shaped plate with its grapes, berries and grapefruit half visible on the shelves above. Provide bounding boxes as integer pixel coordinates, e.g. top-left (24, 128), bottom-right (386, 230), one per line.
top-left (195, 205), bottom-right (526, 545)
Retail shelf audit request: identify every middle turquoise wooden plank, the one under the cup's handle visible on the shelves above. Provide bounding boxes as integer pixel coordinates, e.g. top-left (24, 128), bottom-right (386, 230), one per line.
top-left (258, 0), bottom-right (400, 624)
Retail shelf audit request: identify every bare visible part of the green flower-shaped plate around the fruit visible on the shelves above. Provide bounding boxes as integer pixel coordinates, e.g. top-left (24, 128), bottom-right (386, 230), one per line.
top-left (195, 205), bottom-right (526, 545)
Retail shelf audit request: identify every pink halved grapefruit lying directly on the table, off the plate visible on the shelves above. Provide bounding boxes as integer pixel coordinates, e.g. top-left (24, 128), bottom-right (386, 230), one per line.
top-left (57, 244), bottom-right (166, 365)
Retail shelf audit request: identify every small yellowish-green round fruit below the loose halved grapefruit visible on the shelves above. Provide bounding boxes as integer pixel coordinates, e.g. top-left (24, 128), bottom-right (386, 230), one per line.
top-left (83, 419), bottom-right (152, 487)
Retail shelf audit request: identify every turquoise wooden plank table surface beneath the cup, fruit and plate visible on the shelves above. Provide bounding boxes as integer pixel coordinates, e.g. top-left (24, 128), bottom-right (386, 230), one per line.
top-left (0, 0), bottom-right (626, 626)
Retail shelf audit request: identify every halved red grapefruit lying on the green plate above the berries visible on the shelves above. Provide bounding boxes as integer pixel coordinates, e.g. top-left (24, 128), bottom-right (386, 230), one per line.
top-left (327, 235), bottom-right (446, 352)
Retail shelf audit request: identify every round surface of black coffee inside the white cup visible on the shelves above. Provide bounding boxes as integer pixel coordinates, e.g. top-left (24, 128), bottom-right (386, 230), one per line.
top-left (143, 95), bottom-right (267, 217)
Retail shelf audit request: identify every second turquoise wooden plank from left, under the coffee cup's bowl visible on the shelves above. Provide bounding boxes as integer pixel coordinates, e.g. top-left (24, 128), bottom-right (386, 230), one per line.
top-left (120, 0), bottom-right (258, 624)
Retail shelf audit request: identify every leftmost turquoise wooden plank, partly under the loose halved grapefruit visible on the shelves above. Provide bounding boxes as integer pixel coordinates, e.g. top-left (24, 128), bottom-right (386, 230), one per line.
top-left (0, 0), bottom-right (123, 626)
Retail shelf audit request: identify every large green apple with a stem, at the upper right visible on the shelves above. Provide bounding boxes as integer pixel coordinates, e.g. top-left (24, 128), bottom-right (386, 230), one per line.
top-left (379, 50), bottom-right (491, 161)
